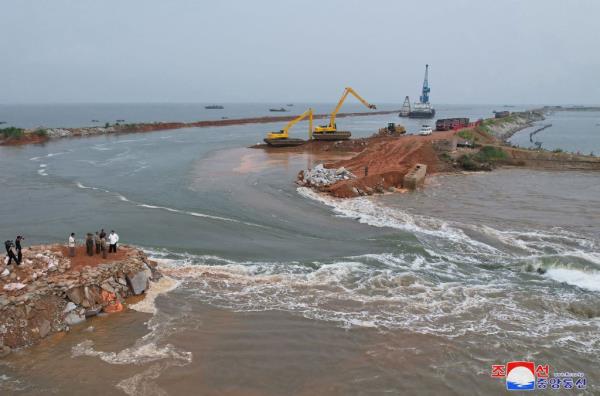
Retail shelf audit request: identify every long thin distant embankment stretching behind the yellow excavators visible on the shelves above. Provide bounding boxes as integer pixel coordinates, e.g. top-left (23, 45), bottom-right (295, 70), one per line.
top-left (0, 110), bottom-right (398, 146)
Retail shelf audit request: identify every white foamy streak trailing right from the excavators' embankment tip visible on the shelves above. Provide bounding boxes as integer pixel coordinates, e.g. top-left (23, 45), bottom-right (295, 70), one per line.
top-left (297, 187), bottom-right (600, 265)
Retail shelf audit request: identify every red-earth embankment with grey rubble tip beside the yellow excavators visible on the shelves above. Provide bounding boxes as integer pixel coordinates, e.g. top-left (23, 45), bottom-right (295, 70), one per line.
top-left (254, 110), bottom-right (600, 198)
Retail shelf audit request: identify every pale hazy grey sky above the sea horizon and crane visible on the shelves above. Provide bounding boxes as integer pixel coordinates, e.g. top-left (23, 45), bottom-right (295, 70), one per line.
top-left (0, 0), bottom-right (600, 104)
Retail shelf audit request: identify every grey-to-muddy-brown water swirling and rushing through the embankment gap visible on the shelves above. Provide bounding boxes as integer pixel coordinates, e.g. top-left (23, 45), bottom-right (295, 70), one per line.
top-left (0, 103), bottom-right (600, 395)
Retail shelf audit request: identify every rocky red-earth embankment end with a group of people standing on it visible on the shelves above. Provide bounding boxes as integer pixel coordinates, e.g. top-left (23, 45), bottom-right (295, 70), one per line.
top-left (0, 245), bottom-right (161, 357)
